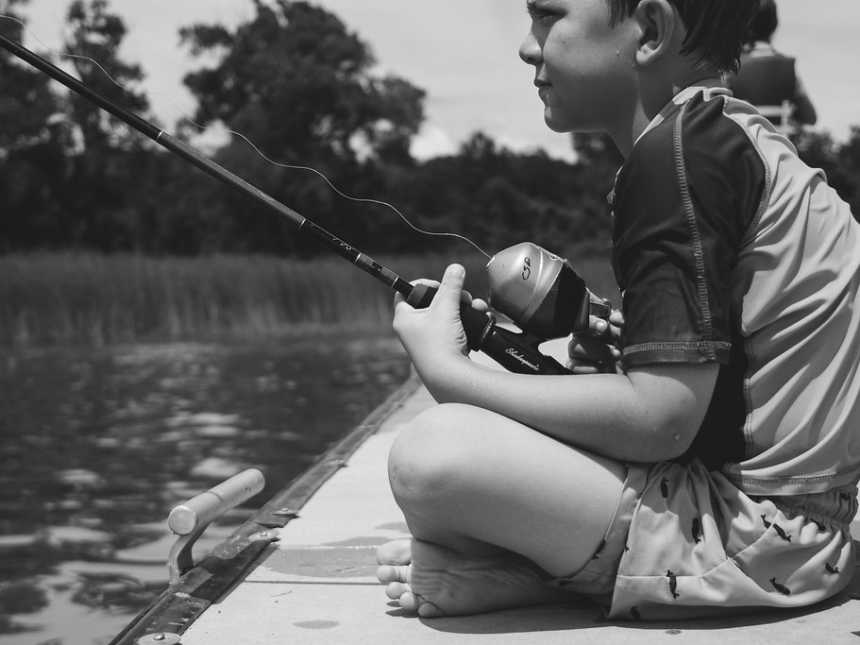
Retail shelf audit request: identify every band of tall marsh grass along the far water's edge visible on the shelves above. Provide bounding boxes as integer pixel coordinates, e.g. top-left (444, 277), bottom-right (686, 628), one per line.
top-left (0, 253), bottom-right (614, 347)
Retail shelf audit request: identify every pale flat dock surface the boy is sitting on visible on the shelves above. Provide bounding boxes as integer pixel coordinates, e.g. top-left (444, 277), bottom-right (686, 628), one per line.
top-left (182, 340), bottom-right (860, 645)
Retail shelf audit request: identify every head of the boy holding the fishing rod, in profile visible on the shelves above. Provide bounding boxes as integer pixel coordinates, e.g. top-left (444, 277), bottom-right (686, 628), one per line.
top-left (520, 0), bottom-right (758, 152)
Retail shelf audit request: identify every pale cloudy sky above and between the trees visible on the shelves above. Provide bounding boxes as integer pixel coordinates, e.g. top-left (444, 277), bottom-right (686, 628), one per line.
top-left (15, 0), bottom-right (860, 158)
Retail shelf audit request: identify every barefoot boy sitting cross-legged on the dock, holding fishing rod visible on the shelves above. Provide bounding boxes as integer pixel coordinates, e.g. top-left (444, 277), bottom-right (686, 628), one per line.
top-left (378, 0), bottom-right (860, 619)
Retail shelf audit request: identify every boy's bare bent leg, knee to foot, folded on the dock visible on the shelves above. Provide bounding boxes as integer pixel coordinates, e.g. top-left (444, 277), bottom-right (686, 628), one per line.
top-left (380, 404), bottom-right (626, 615)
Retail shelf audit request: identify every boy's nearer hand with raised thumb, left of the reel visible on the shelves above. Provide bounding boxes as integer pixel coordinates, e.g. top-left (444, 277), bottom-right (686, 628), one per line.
top-left (392, 264), bottom-right (480, 371)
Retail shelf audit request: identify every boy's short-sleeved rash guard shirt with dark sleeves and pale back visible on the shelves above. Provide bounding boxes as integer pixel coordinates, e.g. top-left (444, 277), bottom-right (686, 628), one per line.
top-left (613, 87), bottom-right (860, 495)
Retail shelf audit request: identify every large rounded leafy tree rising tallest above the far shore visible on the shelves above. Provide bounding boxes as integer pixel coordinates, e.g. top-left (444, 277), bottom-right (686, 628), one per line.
top-left (180, 0), bottom-right (424, 166)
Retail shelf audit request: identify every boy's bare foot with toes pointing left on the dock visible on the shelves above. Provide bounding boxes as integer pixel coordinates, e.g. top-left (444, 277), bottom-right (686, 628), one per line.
top-left (377, 540), bottom-right (569, 618)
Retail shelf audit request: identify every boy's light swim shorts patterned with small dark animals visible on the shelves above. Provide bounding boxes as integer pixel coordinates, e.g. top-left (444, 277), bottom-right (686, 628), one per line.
top-left (555, 460), bottom-right (857, 620)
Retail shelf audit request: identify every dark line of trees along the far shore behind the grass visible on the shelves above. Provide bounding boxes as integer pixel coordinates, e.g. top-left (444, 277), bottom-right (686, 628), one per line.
top-left (0, 0), bottom-right (860, 256)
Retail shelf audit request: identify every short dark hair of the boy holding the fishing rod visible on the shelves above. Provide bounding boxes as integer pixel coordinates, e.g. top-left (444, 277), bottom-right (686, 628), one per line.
top-left (608, 0), bottom-right (762, 72)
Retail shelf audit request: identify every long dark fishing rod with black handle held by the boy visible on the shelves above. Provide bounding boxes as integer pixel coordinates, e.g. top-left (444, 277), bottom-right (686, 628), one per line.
top-left (0, 34), bottom-right (576, 374)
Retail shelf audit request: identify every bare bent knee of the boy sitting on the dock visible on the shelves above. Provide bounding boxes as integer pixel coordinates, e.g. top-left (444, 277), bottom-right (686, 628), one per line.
top-left (388, 404), bottom-right (478, 504)
